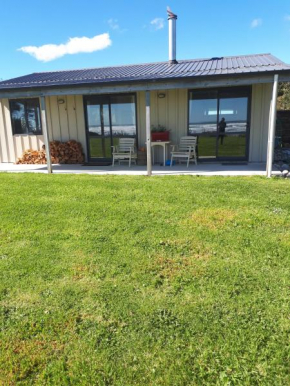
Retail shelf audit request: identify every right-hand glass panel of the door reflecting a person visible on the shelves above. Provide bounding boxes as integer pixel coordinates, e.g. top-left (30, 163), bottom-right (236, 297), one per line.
top-left (217, 97), bottom-right (248, 158)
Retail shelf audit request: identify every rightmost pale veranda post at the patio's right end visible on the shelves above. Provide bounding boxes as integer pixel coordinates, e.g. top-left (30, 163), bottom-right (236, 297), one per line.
top-left (266, 74), bottom-right (279, 178)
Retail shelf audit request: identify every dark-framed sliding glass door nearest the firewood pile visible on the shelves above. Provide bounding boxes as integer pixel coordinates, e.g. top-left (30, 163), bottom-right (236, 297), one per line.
top-left (84, 94), bottom-right (137, 163)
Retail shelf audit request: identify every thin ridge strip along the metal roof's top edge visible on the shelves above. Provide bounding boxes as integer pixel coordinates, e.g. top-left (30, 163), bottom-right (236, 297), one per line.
top-left (29, 52), bottom-right (276, 76)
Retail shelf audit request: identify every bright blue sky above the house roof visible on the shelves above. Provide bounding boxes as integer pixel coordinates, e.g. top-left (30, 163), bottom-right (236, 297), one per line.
top-left (0, 0), bottom-right (290, 80)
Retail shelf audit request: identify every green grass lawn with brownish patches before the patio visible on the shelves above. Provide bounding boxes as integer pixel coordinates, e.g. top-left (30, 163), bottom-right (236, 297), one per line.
top-left (0, 173), bottom-right (290, 386)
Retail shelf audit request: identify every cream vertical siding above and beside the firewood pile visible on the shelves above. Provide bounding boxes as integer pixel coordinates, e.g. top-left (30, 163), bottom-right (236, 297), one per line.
top-left (0, 95), bottom-right (87, 162)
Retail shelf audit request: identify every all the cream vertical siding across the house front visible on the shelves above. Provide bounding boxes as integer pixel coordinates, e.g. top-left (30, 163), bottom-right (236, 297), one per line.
top-left (0, 84), bottom-right (272, 162)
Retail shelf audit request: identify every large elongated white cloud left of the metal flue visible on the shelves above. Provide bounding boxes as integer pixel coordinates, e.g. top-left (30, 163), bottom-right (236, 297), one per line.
top-left (18, 33), bottom-right (112, 62)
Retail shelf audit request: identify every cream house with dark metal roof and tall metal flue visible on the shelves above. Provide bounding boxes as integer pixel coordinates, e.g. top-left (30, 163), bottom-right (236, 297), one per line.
top-left (0, 12), bottom-right (290, 175)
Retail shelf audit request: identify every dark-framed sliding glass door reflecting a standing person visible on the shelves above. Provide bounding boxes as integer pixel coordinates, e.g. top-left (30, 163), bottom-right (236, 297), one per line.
top-left (189, 87), bottom-right (251, 160)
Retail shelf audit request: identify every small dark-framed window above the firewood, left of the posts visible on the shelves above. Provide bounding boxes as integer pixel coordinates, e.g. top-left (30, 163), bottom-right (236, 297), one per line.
top-left (10, 98), bottom-right (42, 134)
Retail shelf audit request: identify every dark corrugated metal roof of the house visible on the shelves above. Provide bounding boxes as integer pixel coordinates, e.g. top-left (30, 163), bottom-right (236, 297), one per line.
top-left (0, 54), bottom-right (290, 90)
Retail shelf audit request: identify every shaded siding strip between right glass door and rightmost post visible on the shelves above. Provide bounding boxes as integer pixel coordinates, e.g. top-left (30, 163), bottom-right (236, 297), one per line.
top-left (249, 83), bottom-right (273, 162)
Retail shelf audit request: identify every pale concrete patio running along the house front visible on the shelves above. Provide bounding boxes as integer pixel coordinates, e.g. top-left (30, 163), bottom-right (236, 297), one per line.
top-left (0, 163), bottom-right (280, 176)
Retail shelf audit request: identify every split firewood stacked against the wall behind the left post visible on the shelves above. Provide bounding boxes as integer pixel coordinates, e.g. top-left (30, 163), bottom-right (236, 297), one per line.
top-left (16, 140), bottom-right (84, 164)
